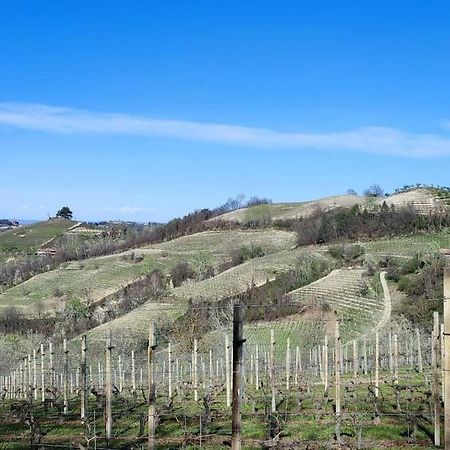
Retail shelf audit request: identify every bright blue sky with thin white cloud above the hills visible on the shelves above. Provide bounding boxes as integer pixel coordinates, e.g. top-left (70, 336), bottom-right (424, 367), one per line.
top-left (0, 0), bottom-right (450, 221)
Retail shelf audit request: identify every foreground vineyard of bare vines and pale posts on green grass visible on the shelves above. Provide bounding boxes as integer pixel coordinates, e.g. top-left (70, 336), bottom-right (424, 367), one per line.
top-left (0, 316), bottom-right (442, 450)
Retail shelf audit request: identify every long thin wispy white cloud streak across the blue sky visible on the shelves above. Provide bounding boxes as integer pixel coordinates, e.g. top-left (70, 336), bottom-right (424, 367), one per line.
top-left (0, 103), bottom-right (450, 157)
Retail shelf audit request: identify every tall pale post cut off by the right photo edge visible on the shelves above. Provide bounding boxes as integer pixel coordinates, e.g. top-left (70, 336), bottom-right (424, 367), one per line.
top-left (442, 250), bottom-right (450, 450)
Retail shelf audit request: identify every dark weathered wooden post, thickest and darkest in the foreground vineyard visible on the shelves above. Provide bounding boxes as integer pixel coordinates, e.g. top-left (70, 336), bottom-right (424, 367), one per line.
top-left (231, 305), bottom-right (245, 450)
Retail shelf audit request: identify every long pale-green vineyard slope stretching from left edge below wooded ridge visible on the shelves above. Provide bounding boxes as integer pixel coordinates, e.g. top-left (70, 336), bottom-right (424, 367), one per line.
top-left (0, 230), bottom-right (295, 315)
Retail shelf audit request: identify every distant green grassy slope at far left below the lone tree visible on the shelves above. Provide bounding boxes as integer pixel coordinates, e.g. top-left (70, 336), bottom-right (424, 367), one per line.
top-left (0, 219), bottom-right (77, 262)
